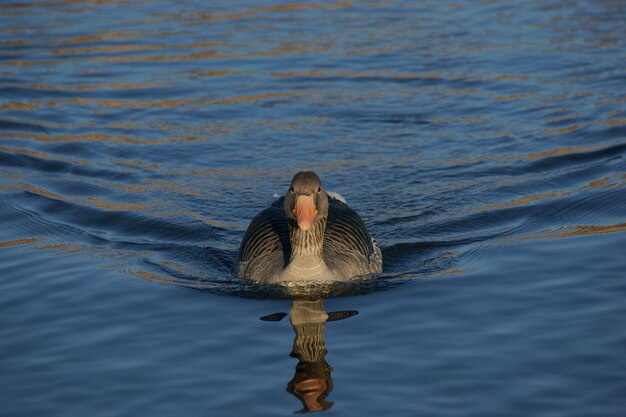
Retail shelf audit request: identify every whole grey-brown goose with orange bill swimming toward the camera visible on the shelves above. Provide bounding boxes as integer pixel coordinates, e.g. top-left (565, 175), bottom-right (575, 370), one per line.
top-left (235, 171), bottom-right (383, 284)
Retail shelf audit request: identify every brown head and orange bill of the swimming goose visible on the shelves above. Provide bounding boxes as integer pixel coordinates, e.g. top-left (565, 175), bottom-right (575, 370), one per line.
top-left (285, 171), bottom-right (328, 231)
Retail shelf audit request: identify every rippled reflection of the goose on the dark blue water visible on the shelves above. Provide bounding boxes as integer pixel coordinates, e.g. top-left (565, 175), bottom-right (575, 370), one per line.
top-left (261, 298), bottom-right (358, 413)
